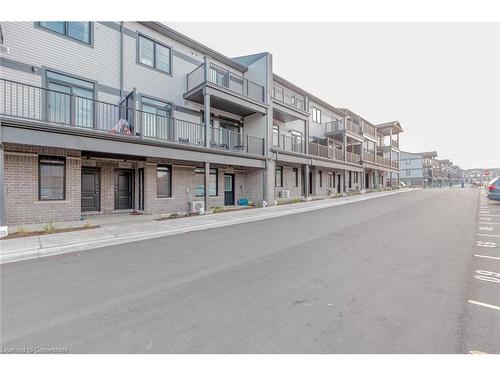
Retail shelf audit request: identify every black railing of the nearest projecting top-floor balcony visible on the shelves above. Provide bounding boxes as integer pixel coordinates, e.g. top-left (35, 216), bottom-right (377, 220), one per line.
top-left (187, 63), bottom-right (264, 102)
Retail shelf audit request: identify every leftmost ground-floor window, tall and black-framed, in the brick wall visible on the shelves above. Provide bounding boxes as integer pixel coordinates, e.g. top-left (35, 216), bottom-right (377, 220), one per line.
top-left (38, 156), bottom-right (66, 201)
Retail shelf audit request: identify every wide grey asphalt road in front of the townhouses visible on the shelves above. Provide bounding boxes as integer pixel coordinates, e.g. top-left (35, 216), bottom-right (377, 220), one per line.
top-left (1, 188), bottom-right (500, 353)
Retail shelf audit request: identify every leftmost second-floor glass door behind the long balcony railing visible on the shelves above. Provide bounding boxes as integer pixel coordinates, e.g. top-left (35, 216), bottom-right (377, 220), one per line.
top-left (47, 72), bottom-right (94, 128)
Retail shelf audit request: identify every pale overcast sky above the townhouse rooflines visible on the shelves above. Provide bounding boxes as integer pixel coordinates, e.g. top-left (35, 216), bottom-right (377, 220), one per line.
top-left (170, 22), bottom-right (500, 169)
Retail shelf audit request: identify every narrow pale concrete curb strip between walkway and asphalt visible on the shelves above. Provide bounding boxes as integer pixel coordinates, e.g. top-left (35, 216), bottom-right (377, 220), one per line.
top-left (0, 189), bottom-right (421, 264)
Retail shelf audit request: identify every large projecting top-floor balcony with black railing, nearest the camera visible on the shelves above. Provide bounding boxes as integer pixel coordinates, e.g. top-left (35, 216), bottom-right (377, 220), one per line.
top-left (184, 62), bottom-right (266, 116)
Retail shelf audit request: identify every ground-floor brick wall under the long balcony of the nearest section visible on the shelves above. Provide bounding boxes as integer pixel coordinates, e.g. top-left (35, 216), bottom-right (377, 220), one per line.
top-left (4, 144), bottom-right (265, 226)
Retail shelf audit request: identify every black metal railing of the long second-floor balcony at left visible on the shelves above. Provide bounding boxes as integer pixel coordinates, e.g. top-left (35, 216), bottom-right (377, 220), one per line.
top-left (0, 79), bottom-right (264, 155)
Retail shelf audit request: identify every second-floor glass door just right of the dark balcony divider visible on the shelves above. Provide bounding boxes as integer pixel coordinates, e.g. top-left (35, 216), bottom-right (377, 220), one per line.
top-left (142, 97), bottom-right (173, 140)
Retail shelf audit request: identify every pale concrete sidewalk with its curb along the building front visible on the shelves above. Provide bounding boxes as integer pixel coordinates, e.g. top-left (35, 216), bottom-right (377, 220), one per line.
top-left (0, 189), bottom-right (418, 264)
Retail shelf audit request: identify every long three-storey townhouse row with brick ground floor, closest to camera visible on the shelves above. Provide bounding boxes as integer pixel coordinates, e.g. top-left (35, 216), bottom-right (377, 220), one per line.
top-left (0, 22), bottom-right (403, 227)
